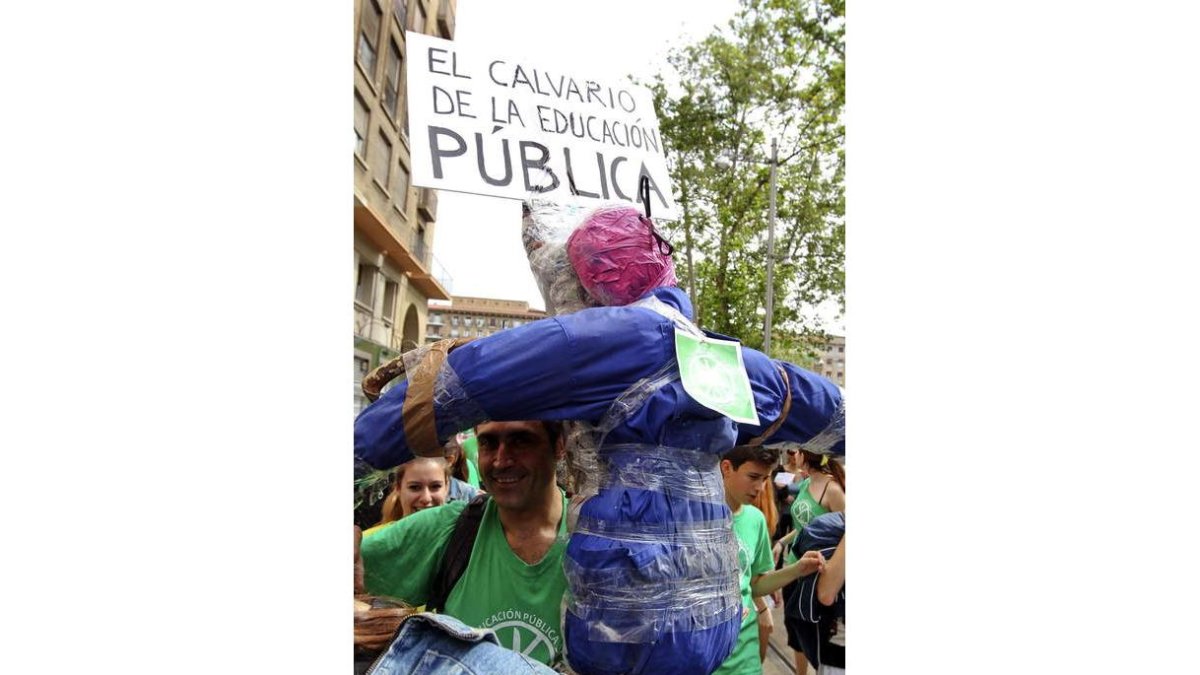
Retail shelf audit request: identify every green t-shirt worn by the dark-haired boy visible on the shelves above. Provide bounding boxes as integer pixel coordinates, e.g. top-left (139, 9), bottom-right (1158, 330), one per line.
top-left (713, 504), bottom-right (775, 675)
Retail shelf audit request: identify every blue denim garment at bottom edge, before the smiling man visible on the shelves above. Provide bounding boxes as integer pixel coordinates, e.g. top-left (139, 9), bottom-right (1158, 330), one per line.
top-left (367, 611), bottom-right (554, 675)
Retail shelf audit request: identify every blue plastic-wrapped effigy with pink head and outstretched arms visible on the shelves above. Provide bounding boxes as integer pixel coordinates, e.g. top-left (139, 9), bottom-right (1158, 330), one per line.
top-left (354, 202), bottom-right (845, 675)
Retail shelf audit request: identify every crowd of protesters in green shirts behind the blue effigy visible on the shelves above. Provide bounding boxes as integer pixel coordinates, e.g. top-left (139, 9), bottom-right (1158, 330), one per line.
top-left (356, 420), bottom-right (845, 675)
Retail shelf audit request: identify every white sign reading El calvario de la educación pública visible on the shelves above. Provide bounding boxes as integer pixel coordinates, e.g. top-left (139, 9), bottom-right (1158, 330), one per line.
top-left (406, 32), bottom-right (677, 220)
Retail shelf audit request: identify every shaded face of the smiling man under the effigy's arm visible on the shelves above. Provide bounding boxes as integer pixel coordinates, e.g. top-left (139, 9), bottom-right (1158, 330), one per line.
top-left (475, 422), bottom-right (558, 510)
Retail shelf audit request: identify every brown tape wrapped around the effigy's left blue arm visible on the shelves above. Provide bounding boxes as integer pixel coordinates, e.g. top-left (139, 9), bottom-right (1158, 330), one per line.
top-left (362, 338), bottom-right (474, 458)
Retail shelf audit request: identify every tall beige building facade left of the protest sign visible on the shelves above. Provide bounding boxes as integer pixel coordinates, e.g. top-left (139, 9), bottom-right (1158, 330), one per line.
top-left (354, 0), bottom-right (457, 413)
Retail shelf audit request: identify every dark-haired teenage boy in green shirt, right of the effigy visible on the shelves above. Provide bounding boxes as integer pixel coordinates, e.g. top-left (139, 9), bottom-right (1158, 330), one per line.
top-left (714, 446), bottom-right (824, 675)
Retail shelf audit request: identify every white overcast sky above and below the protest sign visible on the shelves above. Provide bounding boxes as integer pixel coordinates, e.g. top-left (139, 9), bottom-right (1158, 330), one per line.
top-left (433, 0), bottom-right (738, 309)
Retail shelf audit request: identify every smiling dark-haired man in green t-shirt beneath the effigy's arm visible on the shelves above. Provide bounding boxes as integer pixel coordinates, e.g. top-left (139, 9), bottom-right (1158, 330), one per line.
top-left (360, 422), bottom-right (568, 665)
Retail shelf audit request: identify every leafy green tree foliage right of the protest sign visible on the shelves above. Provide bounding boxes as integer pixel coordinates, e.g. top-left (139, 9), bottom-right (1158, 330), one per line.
top-left (650, 0), bottom-right (845, 356)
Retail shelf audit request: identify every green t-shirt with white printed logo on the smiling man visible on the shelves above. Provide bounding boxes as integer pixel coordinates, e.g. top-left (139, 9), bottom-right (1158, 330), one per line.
top-left (361, 487), bottom-right (568, 665)
